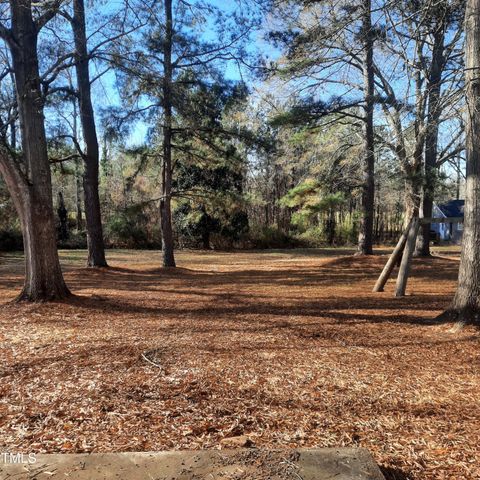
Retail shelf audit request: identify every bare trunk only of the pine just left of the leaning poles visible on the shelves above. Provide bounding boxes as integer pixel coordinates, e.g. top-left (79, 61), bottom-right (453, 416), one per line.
top-left (358, 0), bottom-right (375, 255)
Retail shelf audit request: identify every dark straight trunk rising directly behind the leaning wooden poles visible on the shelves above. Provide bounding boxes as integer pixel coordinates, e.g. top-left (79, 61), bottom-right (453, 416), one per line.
top-left (415, 22), bottom-right (445, 257)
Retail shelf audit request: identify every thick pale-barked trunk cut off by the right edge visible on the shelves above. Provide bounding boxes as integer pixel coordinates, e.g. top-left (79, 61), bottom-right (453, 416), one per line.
top-left (447, 0), bottom-right (480, 325)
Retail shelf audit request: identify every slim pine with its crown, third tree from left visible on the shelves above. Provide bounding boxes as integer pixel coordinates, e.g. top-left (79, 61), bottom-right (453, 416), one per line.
top-left (113, 0), bottom-right (251, 267)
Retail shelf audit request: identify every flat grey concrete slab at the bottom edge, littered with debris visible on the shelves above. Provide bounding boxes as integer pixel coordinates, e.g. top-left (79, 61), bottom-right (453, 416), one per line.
top-left (0, 448), bottom-right (384, 480)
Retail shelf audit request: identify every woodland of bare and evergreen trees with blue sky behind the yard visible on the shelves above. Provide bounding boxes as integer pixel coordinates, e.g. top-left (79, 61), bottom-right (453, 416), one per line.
top-left (0, 0), bottom-right (465, 296)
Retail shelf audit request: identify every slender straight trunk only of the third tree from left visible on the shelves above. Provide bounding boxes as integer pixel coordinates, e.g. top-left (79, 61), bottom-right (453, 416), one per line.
top-left (160, 0), bottom-right (175, 267)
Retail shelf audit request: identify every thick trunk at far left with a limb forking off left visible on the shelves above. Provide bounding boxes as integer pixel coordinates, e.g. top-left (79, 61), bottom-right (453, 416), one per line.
top-left (0, 0), bottom-right (70, 301)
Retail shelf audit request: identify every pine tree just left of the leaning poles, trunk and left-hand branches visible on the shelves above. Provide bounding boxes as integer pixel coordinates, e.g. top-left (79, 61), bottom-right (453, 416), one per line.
top-left (270, 0), bottom-right (380, 255)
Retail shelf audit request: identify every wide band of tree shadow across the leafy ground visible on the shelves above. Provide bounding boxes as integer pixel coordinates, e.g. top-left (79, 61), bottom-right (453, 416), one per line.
top-left (2, 251), bottom-right (458, 330)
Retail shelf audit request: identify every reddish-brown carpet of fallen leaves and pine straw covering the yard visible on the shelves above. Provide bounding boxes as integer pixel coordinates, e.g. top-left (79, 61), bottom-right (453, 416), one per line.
top-left (0, 251), bottom-right (480, 479)
